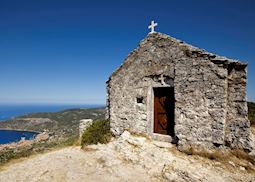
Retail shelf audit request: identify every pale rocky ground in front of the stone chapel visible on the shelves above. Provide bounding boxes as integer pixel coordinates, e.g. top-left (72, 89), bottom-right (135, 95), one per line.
top-left (0, 132), bottom-right (255, 182)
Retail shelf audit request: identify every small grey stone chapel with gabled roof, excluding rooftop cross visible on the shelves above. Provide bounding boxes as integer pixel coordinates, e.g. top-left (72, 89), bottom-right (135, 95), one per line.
top-left (107, 23), bottom-right (253, 151)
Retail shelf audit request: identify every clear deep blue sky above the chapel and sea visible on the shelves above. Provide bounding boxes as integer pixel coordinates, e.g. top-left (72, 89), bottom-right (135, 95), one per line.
top-left (0, 0), bottom-right (255, 104)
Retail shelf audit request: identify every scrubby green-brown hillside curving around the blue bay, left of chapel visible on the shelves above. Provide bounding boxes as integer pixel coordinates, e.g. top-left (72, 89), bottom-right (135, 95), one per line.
top-left (0, 108), bottom-right (105, 165)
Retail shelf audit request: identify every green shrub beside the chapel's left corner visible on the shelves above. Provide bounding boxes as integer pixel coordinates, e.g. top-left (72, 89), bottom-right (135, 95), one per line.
top-left (81, 120), bottom-right (112, 147)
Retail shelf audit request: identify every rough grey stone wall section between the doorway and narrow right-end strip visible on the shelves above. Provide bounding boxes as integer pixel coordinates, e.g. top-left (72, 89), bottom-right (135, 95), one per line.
top-left (174, 57), bottom-right (227, 149)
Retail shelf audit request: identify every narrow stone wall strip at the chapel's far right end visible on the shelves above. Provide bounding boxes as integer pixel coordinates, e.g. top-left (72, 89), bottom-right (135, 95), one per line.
top-left (225, 65), bottom-right (253, 150)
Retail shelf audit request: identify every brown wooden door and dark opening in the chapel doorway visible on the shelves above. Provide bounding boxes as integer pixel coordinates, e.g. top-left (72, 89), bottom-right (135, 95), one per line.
top-left (154, 87), bottom-right (174, 136)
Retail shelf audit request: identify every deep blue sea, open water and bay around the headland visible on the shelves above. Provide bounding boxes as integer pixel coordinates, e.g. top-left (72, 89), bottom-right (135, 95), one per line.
top-left (0, 104), bottom-right (103, 144)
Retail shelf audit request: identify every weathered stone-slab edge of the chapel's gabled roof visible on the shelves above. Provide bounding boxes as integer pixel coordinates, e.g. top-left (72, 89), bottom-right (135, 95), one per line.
top-left (107, 32), bottom-right (247, 82)
